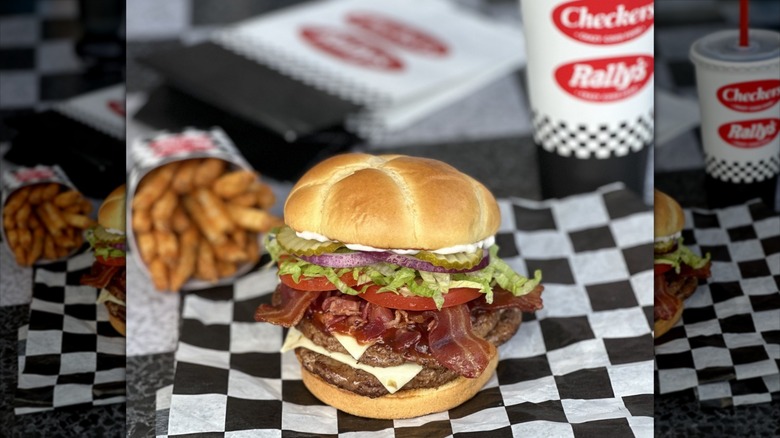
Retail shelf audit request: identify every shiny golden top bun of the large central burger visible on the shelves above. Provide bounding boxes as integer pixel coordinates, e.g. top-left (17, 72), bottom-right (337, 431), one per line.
top-left (284, 154), bottom-right (501, 250)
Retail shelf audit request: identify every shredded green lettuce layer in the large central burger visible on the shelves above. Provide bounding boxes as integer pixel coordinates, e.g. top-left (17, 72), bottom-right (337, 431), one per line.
top-left (265, 224), bottom-right (542, 309)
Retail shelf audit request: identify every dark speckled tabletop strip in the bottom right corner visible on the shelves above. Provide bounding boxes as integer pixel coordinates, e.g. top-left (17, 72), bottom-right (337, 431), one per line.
top-left (655, 393), bottom-right (780, 438)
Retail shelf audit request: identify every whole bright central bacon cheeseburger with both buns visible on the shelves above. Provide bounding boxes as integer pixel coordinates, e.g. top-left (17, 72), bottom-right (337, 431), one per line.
top-left (255, 154), bottom-right (543, 419)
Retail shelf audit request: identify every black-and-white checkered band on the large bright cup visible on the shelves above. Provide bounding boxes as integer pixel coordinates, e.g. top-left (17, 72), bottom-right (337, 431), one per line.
top-left (533, 112), bottom-right (654, 159)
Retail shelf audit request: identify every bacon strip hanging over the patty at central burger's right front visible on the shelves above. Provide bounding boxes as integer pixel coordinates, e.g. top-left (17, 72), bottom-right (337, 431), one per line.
top-left (428, 305), bottom-right (490, 378)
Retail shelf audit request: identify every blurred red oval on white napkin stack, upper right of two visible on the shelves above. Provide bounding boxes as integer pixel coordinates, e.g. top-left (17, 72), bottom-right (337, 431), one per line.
top-left (346, 12), bottom-right (449, 57)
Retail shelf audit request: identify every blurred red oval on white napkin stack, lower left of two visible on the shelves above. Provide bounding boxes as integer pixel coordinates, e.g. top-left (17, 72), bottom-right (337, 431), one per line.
top-left (300, 26), bottom-right (404, 72)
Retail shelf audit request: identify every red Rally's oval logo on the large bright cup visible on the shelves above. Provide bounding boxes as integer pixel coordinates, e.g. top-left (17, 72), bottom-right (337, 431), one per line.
top-left (555, 55), bottom-right (653, 102)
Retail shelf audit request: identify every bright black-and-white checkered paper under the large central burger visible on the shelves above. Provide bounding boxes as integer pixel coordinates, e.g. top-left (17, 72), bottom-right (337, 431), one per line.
top-left (157, 186), bottom-right (653, 437)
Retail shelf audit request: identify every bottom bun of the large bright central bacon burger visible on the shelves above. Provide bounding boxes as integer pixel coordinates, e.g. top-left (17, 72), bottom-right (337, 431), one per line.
top-left (301, 345), bottom-right (498, 420)
